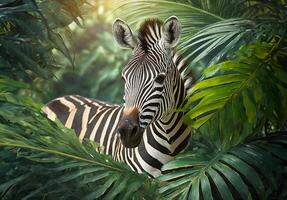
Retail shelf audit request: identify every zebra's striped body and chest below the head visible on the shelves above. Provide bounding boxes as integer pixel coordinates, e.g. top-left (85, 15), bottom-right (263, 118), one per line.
top-left (43, 95), bottom-right (190, 176)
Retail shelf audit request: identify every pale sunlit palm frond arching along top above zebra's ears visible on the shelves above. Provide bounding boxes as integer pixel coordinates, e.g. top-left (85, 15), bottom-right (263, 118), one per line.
top-left (115, 0), bottom-right (244, 30)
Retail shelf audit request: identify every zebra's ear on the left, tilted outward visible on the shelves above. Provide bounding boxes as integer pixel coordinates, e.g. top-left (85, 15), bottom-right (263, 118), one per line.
top-left (113, 19), bottom-right (137, 49)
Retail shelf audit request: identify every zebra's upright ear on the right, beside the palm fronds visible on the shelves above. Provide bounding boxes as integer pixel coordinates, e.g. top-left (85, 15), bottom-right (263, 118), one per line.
top-left (162, 16), bottom-right (181, 48)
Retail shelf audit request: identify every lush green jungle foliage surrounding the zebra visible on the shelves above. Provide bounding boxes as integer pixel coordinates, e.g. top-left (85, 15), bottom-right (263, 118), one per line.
top-left (0, 0), bottom-right (287, 200)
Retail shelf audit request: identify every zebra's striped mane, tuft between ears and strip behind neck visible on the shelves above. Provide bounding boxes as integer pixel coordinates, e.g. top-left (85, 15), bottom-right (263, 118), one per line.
top-left (138, 18), bottom-right (195, 90)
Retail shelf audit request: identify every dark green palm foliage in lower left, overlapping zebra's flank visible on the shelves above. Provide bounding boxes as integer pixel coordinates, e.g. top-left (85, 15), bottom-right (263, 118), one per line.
top-left (0, 94), bottom-right (156, 199)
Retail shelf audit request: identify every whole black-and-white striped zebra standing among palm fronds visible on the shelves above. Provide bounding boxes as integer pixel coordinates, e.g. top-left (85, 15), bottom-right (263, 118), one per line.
top-left (42, 16), bottom-right (193, 177)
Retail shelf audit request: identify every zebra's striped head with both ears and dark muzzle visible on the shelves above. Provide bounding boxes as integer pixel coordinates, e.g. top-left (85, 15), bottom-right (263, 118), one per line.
top-left (113, 16), bottom-right (181, 148)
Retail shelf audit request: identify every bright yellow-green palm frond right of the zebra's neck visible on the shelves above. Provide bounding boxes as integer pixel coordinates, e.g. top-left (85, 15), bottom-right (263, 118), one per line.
top-left (185, 42), bottom-right (287, 142)
